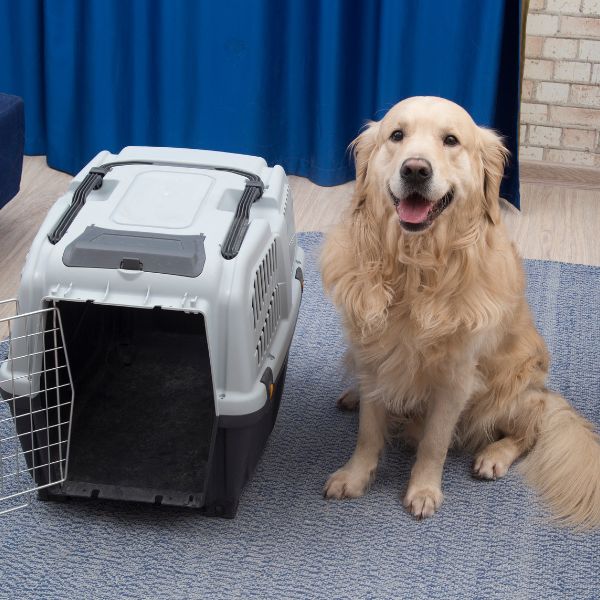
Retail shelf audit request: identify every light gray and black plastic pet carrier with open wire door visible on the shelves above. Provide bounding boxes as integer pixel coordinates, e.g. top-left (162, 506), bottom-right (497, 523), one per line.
top-left (0, 147), bottom-right (303, 517)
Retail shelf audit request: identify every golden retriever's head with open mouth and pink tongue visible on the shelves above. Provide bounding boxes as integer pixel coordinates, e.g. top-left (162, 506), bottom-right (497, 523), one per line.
top-left (353, 97), bottom-right (508, 233)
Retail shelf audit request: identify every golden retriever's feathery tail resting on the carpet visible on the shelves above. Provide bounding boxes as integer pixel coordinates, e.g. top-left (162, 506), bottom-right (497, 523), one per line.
top-left (521, 392), bottom-right (600, 529)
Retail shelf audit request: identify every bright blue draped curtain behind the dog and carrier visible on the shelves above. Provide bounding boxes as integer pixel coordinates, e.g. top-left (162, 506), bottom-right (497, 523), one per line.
top-left (0, 0), bottom-right (520, 206)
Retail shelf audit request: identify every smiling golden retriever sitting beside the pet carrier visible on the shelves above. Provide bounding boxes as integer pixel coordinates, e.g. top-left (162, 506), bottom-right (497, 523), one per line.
top-left (321, 97), bottom-right (600, 528)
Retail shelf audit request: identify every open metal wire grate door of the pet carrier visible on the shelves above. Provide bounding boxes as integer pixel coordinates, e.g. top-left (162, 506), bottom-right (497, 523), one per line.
top-left (0, 300), bottom-right (73, 514)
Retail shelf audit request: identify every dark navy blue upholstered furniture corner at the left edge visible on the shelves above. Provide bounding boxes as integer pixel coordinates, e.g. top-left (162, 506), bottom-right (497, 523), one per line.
top-left (0, 94), bottom-right (25, 208)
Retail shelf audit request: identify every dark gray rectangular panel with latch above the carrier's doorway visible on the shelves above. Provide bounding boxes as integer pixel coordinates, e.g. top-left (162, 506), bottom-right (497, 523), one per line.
top-left (63, 225), bottom-right (206, 277)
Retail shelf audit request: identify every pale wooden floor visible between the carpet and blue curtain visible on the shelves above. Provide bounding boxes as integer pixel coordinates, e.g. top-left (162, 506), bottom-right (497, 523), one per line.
top-left (0, 156), bottom-right (600, 313)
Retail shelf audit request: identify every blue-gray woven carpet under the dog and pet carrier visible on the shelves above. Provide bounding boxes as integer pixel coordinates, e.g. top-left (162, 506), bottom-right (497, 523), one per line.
top-left (0, 234), bottom-right (600, 600)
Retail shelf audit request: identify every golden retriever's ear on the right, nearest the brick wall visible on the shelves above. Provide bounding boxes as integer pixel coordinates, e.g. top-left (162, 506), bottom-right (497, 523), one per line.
top-left (479, 127), bottom-right (510, 225)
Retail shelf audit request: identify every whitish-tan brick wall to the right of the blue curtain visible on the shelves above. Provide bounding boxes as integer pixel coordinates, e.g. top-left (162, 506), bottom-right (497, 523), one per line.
top-left (520, 0), bottom-right (600, 167)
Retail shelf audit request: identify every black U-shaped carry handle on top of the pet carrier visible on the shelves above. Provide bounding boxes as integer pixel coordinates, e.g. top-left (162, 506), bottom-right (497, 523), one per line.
top-left (48, 160), bottom-right (265, 260)
